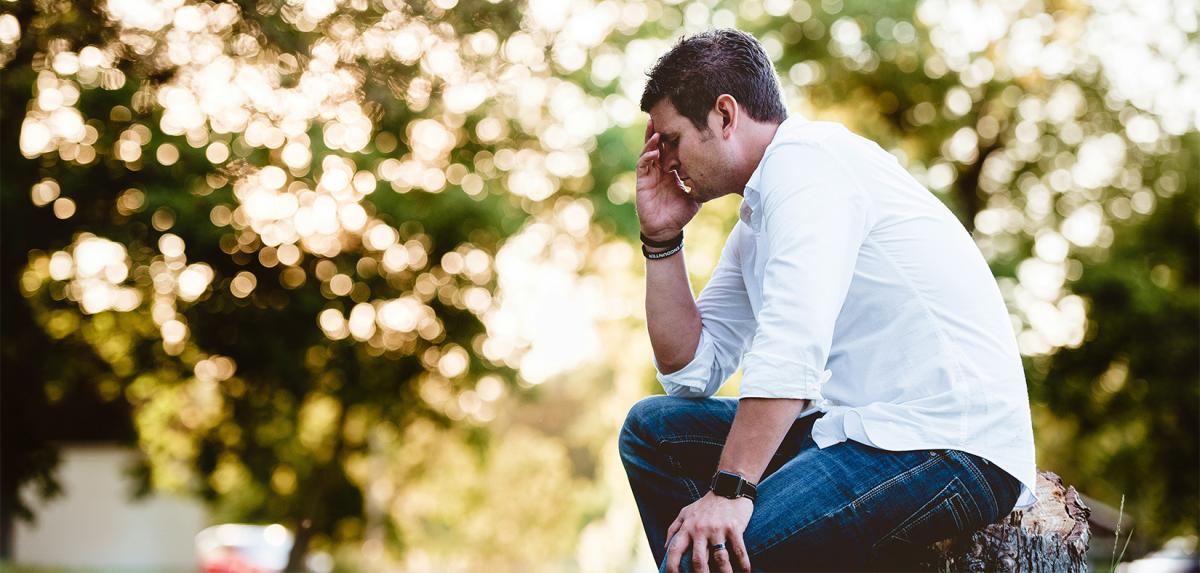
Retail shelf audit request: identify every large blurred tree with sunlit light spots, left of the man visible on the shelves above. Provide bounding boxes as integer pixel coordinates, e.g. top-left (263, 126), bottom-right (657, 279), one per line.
top-left (0, 0), bottom-right (601, 568)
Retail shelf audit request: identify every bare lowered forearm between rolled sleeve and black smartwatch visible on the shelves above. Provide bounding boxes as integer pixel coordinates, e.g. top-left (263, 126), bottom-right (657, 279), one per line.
top-left (718, 398), bottom-right (810, 483)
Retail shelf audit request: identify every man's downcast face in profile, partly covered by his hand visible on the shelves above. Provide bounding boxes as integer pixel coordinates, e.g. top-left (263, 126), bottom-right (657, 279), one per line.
top-left (650, 98), bottom-right (742, 203)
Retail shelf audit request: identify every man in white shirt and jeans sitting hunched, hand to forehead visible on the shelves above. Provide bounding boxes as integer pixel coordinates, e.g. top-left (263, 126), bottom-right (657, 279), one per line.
top-left (620, 30), bottom-right (1036, 572)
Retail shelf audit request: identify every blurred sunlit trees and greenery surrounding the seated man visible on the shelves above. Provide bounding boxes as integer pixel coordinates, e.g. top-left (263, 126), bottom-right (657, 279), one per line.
top-left (0, 0), bottom-right (1200, 573)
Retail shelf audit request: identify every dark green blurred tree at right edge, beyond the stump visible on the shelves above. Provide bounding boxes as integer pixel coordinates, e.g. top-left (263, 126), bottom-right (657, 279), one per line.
top-left (1038, 132), bottom-right (1200, 539)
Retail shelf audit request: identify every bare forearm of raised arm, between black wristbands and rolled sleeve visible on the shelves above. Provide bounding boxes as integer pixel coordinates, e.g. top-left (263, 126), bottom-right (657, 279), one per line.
top-left (646, 252), bottom-right (700, 374)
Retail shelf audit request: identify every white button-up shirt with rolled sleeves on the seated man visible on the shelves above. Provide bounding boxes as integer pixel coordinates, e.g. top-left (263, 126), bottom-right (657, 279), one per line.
top-left (654, 113), bottom-right (1037, 508)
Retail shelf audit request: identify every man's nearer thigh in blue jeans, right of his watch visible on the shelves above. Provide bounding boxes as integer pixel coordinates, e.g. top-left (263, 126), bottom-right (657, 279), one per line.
top-left (744, 441), bottom-right (998, 571)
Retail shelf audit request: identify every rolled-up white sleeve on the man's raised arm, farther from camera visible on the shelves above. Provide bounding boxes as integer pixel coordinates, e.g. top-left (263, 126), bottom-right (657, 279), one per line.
top-left (650, 223), bottom-right (755, 398)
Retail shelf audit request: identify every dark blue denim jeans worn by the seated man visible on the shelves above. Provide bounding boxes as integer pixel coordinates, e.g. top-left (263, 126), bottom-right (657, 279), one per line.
top-left (620, 396), bottom-right (1020, 571)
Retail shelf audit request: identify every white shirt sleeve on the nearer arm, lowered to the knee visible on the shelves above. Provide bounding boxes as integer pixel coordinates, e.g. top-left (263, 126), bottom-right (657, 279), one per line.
top-left (740, 143), bottom-right (870, 402)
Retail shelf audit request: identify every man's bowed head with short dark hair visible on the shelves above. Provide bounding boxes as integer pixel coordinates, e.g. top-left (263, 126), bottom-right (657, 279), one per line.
top-left (642, 29), bottom-right (787, 201)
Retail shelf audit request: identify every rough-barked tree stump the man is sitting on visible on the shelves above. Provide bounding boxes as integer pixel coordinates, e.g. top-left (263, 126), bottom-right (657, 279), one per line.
top-left (920, 471), bottom-right (1091, 573)
